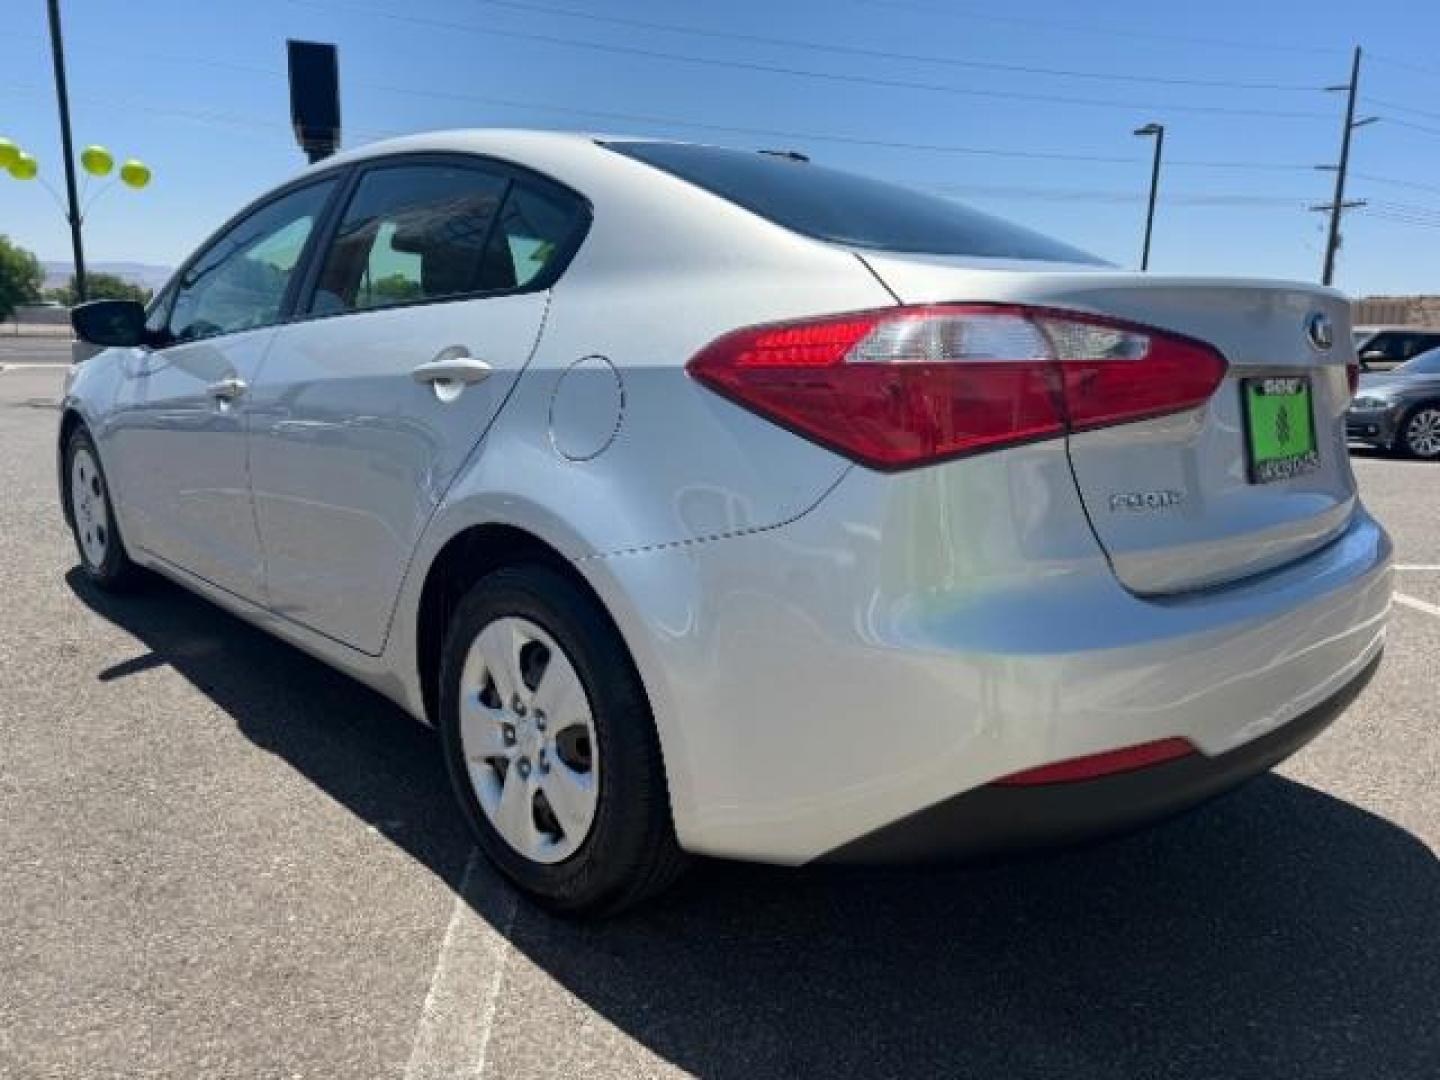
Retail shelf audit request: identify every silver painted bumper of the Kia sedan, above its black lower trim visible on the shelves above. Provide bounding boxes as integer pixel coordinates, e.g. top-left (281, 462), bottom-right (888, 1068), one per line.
top-left (585, 444), bottom-right (1392, 864)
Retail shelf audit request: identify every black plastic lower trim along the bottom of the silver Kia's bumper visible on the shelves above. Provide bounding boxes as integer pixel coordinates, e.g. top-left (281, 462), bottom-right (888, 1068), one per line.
top-left (816, 654), bottom-right (1381, 864)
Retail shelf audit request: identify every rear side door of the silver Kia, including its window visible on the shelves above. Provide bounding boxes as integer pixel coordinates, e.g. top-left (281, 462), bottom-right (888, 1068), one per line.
top-left (249, 156), bottom-right (589, 654)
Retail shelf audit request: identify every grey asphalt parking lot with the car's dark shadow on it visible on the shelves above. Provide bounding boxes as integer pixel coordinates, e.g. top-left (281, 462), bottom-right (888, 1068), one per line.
top-left (0, 364), bottom-right (1440, 1080)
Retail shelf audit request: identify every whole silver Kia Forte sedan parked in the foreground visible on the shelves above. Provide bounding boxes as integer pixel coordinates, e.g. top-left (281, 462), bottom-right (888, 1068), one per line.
top-left (58, 131), bottom-right (1391, 913)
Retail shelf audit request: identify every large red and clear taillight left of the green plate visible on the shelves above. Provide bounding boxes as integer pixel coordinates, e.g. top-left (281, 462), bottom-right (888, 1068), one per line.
top-left (688, 304), bottom-right (1225, 469)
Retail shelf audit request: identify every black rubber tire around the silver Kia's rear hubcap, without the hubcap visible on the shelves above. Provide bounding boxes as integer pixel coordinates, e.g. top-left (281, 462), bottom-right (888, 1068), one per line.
top-left (439, 564), bottom-right (685, 916)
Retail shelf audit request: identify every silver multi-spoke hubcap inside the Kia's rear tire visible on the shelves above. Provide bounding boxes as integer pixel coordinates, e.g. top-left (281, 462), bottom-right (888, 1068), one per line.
top-left (459, 616), bottom-right (600, 863)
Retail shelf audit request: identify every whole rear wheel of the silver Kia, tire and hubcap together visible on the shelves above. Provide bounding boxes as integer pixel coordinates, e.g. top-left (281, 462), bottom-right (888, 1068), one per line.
top-left (439, 566), bottom-right (683, 914)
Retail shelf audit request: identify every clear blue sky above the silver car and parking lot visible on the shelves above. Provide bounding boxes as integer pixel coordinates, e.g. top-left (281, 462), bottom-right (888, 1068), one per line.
top-left (0, 0), bottom-right (1440, 294)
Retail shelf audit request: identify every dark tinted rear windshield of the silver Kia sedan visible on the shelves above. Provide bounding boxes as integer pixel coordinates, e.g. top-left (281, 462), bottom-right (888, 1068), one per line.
top-left (605, 141), bottom-right (1103, 265)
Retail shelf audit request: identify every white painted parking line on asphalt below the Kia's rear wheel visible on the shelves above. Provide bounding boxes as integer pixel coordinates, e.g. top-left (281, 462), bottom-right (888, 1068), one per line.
top-left (405, 848), bottom-right (518, 1080)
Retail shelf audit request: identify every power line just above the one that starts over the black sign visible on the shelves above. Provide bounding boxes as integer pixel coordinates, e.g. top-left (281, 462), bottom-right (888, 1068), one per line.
top-left (440, 0), bottom-right (1320, 91)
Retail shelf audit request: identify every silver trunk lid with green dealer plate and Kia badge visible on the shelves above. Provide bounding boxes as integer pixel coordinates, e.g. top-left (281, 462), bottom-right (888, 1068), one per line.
top-left (865, 253), bottom-right (1355, 595)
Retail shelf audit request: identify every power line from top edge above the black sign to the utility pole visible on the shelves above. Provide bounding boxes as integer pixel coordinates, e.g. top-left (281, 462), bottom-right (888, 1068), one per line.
top-left (288, 0), bottom-right (1328, 120)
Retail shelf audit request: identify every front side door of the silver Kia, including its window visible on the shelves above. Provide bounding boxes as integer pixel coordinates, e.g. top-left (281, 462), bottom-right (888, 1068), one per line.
top-left (107, 180), bottom-right (336, 602)
